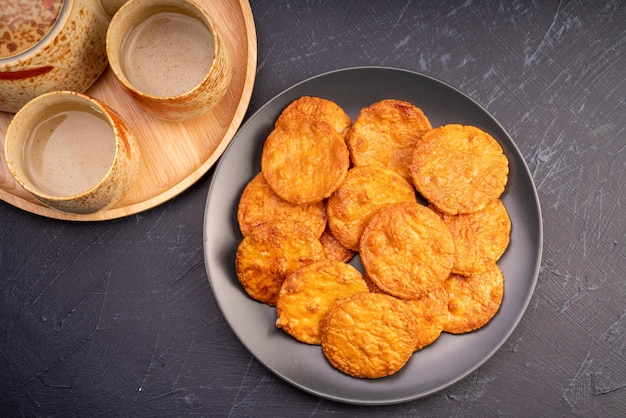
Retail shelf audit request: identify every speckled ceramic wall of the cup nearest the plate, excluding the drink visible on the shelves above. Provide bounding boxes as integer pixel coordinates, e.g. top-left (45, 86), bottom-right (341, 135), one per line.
top-left (106, 0), bottom-right (232, 121)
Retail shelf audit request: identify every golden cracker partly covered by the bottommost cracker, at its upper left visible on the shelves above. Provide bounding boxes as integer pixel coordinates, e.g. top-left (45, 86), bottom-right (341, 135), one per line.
top-left (276, 260), bottom-right (368, 345)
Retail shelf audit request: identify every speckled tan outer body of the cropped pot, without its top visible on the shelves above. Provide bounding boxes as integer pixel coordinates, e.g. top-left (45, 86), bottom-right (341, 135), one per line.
top-left (0, 0), bottom-right (110, 112)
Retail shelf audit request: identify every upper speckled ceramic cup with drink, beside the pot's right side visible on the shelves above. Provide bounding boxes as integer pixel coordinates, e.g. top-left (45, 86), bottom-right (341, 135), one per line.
top-left (107, 0), bottom-right (232, 120)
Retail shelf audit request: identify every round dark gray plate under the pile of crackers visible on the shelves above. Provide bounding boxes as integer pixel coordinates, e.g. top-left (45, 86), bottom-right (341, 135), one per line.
top-left (204, 67), bottom-right (543, 405)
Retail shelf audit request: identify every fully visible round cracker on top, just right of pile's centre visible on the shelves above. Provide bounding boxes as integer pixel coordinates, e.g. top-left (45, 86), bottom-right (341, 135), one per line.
top-left (360, 202), bottom-right (454, 299)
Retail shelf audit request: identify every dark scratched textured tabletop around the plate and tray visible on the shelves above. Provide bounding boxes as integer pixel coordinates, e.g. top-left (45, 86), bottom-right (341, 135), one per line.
top-left (0, 0), bottom-right (626, 417)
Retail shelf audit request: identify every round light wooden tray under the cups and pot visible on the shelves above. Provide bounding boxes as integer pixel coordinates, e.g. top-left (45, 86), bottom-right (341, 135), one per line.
top-left (0, 0), bottom-right (257, 221)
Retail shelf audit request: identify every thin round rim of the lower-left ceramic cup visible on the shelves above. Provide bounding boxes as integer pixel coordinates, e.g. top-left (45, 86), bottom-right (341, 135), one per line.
top-left (4, 90), bottom-right (120, 202)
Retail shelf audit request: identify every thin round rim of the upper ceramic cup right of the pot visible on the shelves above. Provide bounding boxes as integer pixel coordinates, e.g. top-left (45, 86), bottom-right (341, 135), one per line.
top-left (106, 0), bottom-right (222, 102)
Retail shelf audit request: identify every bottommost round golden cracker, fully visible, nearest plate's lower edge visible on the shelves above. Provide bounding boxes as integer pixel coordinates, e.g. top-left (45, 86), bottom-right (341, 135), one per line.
top-left (321, 293), bottom-right (416, 379)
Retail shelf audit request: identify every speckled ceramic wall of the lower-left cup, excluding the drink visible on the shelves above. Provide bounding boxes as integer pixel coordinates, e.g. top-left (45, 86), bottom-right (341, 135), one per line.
top-left (4, 91), bottom-right (140, 213)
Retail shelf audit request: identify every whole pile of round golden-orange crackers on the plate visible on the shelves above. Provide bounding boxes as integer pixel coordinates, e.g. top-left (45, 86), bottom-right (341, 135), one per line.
top-left (236, 96), bottom-right (511, 378)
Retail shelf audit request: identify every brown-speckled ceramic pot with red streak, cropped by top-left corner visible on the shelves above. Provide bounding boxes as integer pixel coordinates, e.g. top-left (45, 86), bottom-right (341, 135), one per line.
top-left (0, 0), bottom-right (110, 113)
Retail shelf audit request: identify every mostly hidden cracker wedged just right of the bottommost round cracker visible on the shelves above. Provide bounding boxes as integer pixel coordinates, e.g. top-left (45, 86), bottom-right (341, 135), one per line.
top-left (405, 286), bottom-right (448, 350)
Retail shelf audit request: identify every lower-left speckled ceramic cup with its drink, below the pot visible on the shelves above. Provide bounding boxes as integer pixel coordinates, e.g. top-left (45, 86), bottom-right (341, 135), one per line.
top-left (4, 91), bottom-right (139, 213)
